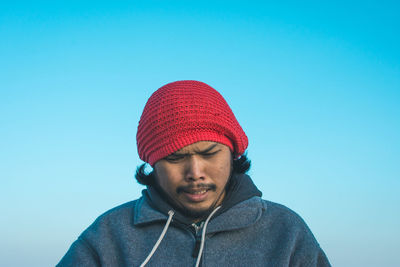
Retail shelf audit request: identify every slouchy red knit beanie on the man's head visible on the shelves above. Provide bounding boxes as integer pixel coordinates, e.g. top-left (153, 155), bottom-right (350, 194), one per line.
top-left (136, 81), bottom-right (248, 166)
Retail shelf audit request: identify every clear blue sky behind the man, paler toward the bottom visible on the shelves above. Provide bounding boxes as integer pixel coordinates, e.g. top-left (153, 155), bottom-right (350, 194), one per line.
top-left (0, 0), bottom-right (400, 267)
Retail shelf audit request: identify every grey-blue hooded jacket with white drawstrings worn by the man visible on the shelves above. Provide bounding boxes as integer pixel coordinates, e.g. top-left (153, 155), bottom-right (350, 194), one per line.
top-left (57, 177), bottom-right (330, 266)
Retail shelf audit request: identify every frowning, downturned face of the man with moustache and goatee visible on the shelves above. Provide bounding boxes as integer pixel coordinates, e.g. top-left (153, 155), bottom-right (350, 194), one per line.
top-left (154, 141), bottom-right (232, 221)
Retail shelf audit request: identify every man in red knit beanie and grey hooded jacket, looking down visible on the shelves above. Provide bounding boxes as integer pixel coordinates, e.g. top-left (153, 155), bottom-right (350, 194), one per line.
top-left (59, 81), bottom-right (330, 266)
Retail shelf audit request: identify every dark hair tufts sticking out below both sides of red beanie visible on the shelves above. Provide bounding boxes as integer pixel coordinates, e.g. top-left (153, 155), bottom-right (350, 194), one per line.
top-left (135, 153), bottom-right (251, 185)
